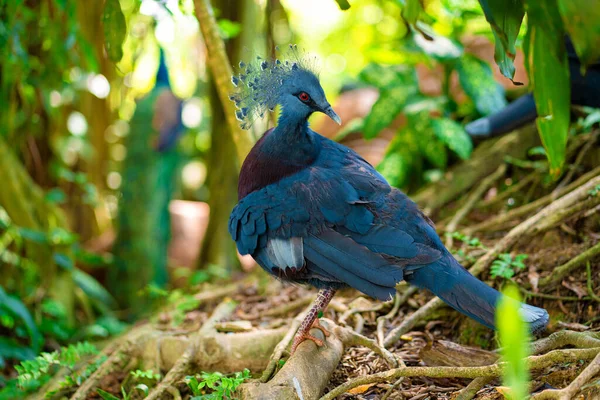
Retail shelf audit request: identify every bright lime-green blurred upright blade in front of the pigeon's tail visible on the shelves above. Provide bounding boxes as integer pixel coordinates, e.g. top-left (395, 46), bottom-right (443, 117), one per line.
top-left (496, 286), bottom-right (529, 400)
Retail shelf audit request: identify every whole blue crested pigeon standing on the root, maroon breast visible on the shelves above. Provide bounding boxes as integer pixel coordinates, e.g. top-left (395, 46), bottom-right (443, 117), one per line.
top-left (229, 47), bottom-right (548, 352)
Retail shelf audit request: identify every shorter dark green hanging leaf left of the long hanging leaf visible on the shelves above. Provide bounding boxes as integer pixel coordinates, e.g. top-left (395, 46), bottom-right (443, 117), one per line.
top-left (479, 0), bottom-right (525, 83)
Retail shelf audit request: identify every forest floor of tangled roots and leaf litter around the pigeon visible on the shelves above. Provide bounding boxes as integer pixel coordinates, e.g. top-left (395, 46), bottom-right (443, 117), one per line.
top-left (21, 126), bottom-right (600, 400)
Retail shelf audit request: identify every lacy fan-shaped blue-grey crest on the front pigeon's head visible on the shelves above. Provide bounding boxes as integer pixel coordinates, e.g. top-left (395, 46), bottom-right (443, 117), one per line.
top-left (229, 45), bottom-right (317, 129)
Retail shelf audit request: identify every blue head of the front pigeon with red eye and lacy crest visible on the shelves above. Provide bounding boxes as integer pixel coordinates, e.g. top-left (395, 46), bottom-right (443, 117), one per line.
top-left (229, 45), bottom-right (341, 129)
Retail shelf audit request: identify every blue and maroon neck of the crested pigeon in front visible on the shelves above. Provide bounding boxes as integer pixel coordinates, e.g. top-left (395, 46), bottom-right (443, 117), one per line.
top-left (238, 117), bottom-right (320, 200)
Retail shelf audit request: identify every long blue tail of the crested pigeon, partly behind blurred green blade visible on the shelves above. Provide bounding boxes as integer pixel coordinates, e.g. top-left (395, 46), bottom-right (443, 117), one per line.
top-left (406, 254), bottom-right (549, 333)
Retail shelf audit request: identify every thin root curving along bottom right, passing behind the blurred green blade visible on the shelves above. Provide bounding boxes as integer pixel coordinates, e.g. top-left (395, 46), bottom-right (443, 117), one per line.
top-left (320, 347), bottom-right (600, 400)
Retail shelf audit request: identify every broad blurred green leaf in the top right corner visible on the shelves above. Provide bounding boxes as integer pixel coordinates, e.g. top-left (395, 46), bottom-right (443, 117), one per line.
top-left (558, 0), bottom-right (600, 70)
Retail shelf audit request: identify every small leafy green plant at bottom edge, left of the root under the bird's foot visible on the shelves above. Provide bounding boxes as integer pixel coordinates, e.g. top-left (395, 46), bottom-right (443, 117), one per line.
top-left (185, 369), bottom-right (250, 400)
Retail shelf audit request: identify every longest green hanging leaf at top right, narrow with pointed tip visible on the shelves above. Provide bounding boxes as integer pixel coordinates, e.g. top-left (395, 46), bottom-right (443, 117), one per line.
top-left (525, 0), bottom-right (571, 179)
